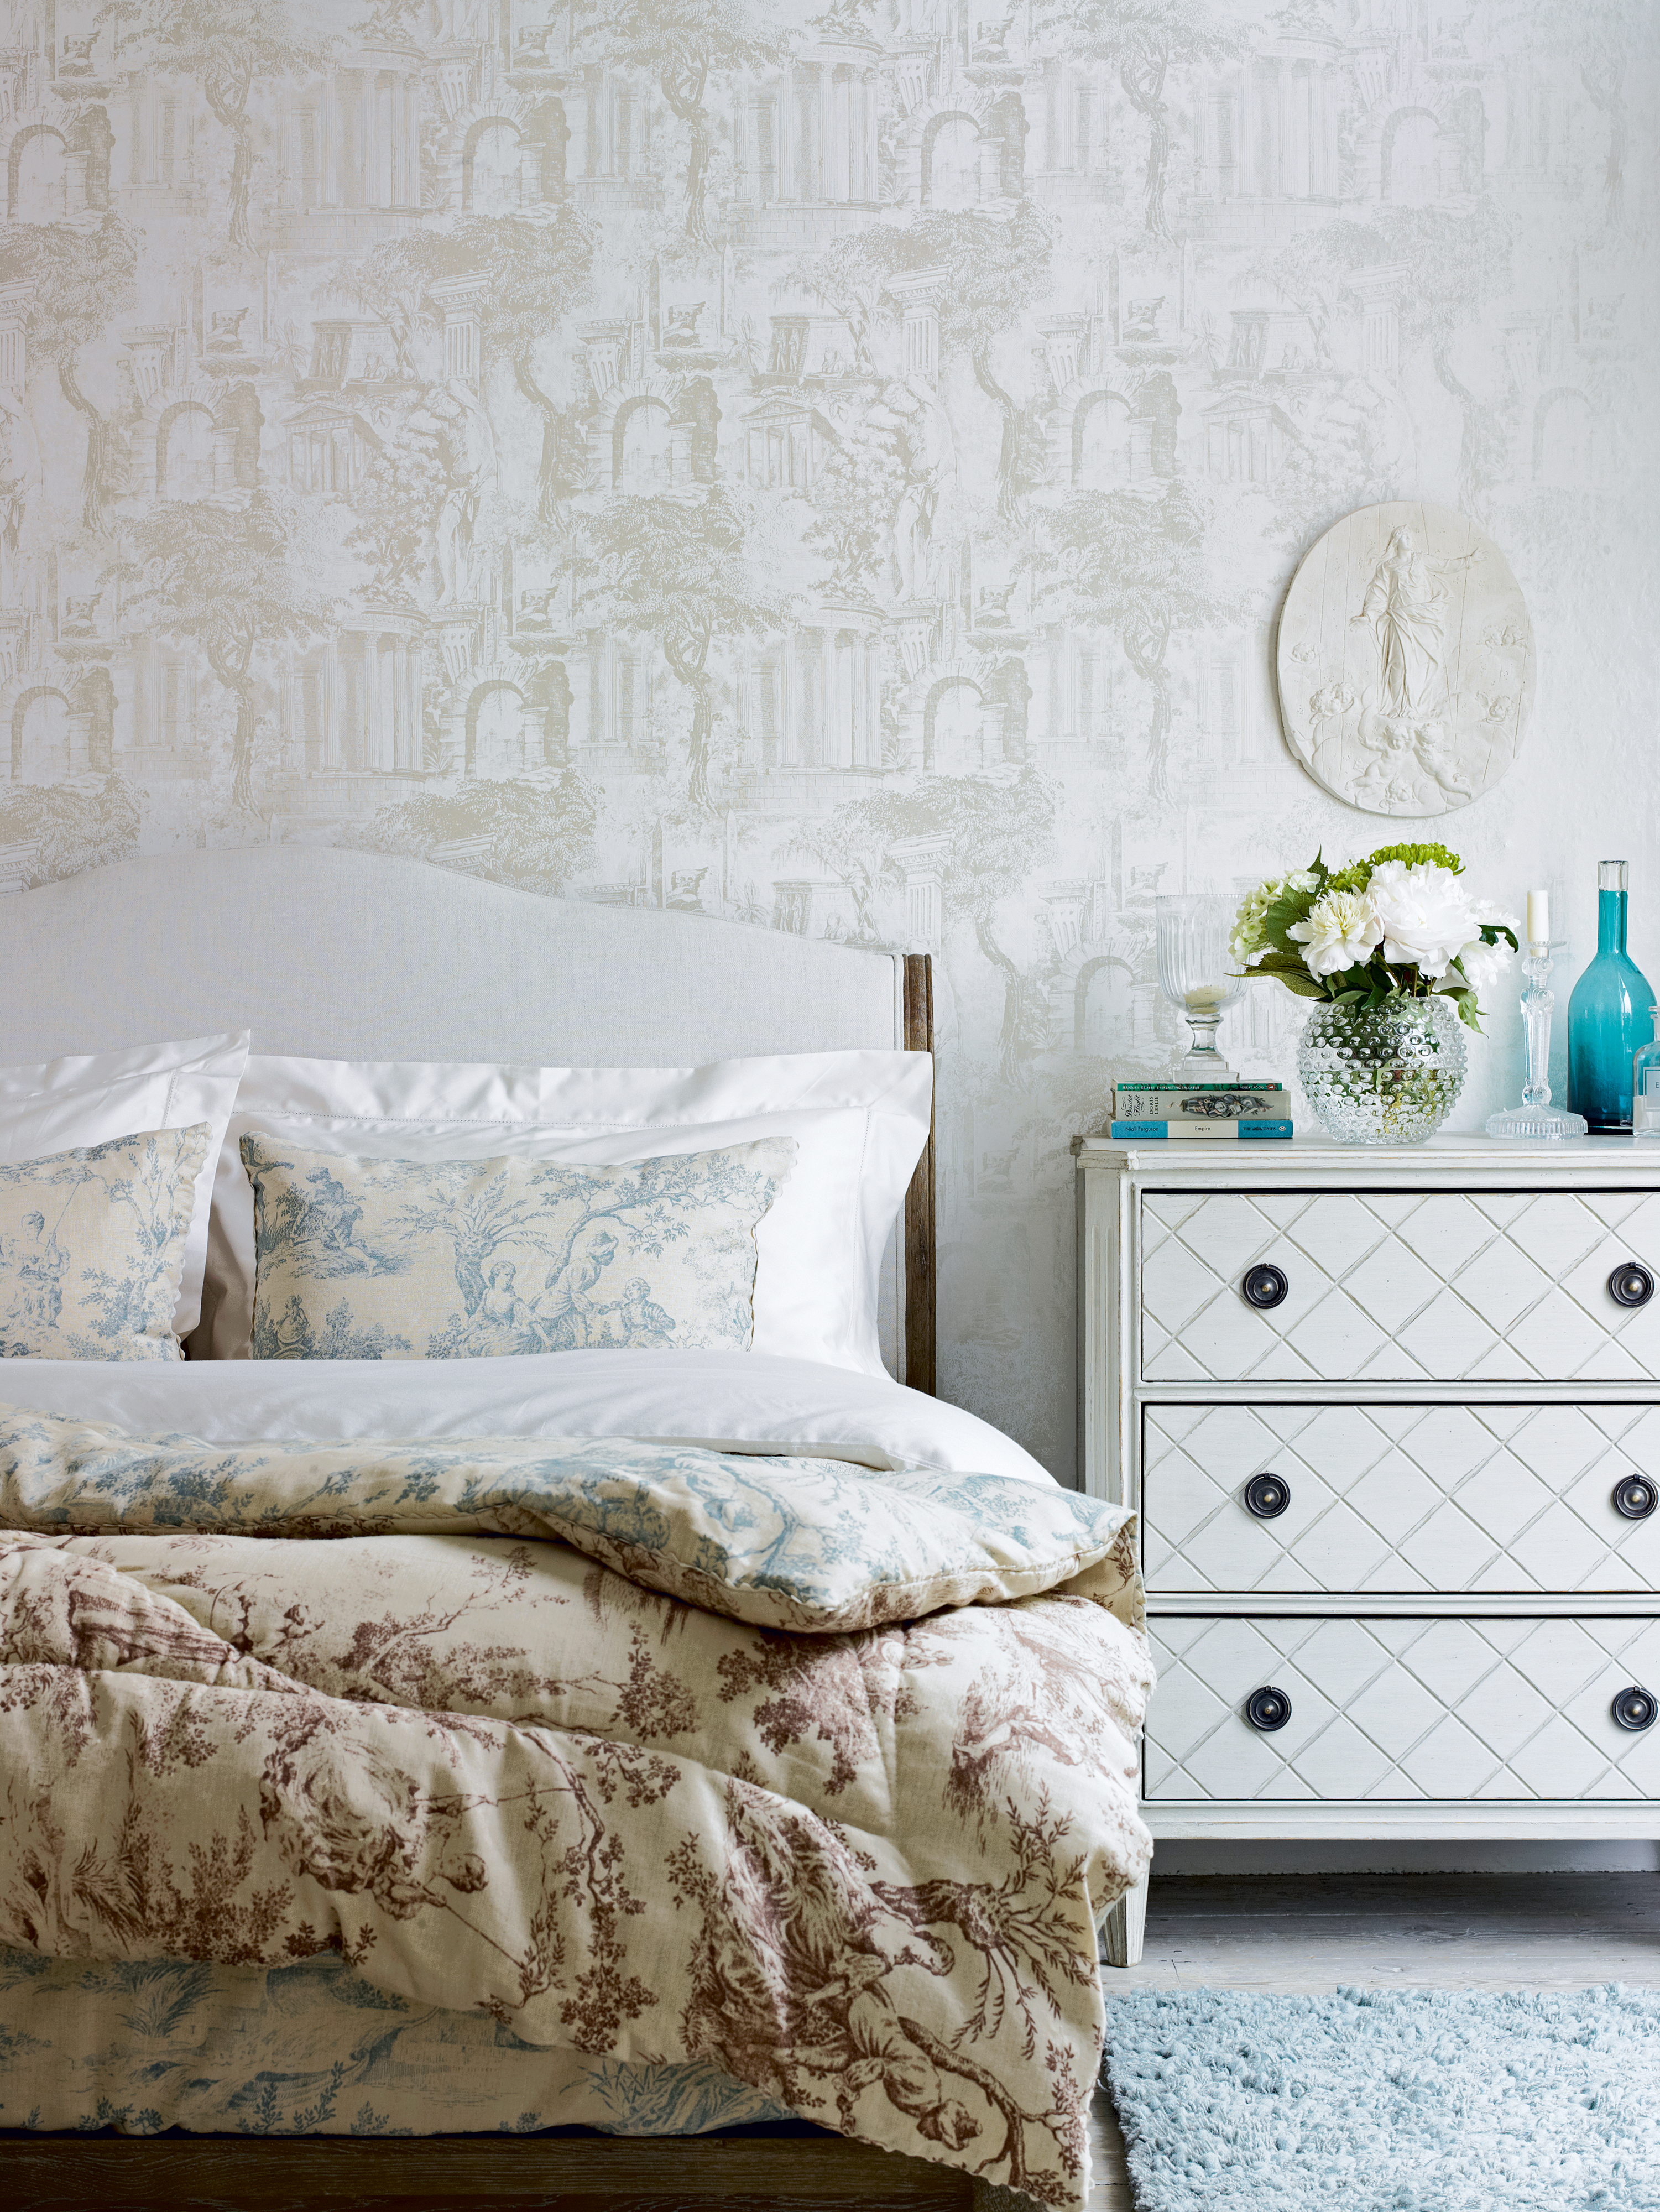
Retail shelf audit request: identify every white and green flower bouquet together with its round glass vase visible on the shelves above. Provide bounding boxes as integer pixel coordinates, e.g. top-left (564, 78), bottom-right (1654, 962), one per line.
top-left (1230, 845), bottom-right (1516, 1144)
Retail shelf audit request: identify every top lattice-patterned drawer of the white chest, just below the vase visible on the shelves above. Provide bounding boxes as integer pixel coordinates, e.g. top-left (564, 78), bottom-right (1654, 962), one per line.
top-left (1140, 1194), bottom-right (1660, 1383)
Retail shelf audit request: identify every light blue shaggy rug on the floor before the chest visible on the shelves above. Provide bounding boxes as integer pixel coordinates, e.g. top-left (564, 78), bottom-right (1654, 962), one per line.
top-left (1104, 1984), bottom-right (1660, 2212)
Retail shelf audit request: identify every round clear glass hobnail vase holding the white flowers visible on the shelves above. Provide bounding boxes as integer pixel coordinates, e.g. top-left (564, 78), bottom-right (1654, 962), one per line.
top-left (1297, 995), bottom-right (1468, 1144)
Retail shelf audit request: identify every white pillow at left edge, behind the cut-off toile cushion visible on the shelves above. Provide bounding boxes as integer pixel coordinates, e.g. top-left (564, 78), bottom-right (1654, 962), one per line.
top-left (0, 1029), bottom-right (248, 1336)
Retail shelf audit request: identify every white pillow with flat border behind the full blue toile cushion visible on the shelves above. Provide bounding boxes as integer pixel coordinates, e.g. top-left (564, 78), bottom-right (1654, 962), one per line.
top-left (190, 1053), bottom-right (934, 1374)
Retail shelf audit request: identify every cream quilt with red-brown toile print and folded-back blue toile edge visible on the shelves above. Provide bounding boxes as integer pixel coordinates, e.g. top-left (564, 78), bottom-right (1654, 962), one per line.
top-left (0, 1409), bottom-right (1151, 2208)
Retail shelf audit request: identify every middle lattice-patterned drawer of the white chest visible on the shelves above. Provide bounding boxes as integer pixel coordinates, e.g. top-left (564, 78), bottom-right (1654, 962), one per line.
top-left (1142, 1405), bottom-right (1660, 1595)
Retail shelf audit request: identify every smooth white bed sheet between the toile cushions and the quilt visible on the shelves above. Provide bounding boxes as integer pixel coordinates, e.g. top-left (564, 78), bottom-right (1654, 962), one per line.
top-left (0, 1352), bottom-right (1051, 1482)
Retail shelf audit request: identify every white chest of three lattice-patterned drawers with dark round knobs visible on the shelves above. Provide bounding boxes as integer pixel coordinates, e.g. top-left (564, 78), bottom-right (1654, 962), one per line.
top-left (1078, 1137), bottom-right (1660, 1962)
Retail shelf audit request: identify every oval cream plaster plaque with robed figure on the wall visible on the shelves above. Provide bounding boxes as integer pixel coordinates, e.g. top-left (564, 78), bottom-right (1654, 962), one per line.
top-left (1275, 500), bottom-right (1534, 814)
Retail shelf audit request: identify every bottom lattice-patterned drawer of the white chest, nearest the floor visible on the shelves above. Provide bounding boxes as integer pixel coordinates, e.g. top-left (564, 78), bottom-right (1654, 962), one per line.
top-left (1144, 1617), bottom-right (1660, 1805)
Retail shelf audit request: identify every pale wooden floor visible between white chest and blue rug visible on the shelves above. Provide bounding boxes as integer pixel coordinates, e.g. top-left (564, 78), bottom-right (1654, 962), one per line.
top-left (1089, 1874), bottom-right (1660, 2212)
